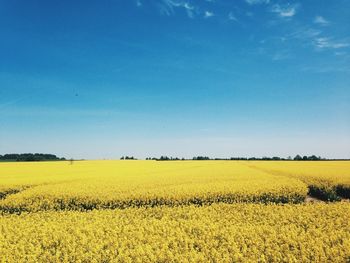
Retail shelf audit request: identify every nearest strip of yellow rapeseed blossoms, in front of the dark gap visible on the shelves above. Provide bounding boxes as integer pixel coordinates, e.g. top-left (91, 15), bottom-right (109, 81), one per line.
top-left (0, 202), bottom-right (350, 263)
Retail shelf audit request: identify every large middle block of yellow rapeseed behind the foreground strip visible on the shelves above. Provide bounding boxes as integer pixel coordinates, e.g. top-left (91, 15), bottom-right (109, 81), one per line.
top-left (0, 161), bottom-right (307, 213)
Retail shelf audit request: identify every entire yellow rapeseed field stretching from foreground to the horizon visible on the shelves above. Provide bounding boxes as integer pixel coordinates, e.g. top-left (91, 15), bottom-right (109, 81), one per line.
top-left (0, 161), bottom-right (350, 262)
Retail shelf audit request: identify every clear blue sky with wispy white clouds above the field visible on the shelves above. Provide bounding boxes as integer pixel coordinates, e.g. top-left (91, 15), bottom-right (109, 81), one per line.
top-left (0, 0), bottom-right (350, 158)
